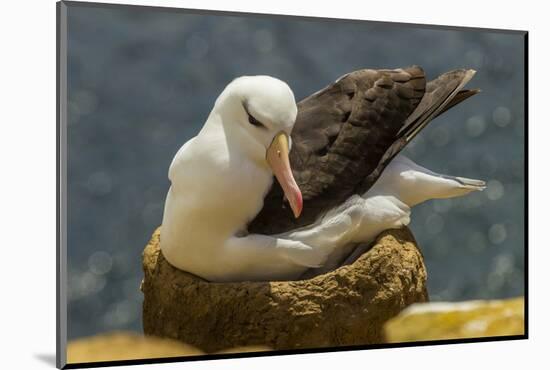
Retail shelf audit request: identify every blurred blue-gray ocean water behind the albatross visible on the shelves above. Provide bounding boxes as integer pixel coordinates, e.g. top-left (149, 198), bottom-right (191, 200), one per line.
top-left (68, 5), bottom-right (525, 339)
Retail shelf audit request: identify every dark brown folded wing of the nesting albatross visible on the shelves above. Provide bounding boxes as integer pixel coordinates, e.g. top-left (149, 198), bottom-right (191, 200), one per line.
top-left (248, 66), bottom-right (475, 234)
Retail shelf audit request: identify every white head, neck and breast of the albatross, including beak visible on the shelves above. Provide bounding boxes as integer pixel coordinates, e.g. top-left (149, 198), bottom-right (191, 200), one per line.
top-left (161, 76), bottom-right (325, 281)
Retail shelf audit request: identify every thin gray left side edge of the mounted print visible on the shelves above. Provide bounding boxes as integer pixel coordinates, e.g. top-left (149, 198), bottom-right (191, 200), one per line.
top-left (55, 1), bottom-right (68, 369)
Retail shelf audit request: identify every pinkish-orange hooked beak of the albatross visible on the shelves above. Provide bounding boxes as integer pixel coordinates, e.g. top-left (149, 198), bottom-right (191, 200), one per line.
top-left (266, 131), bottom-right (303, 218)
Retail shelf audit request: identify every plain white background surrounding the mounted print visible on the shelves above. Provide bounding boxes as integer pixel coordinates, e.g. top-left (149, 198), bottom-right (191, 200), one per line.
top-left (0, 0), bottom-right (550, 369)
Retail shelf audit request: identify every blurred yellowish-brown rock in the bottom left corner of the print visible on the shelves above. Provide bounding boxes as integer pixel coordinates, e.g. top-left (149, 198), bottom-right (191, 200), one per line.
top-left (67, 332), bottom-right (203, 364)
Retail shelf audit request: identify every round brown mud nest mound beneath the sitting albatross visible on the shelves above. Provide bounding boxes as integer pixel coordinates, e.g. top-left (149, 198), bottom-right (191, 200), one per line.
top-left (142, 225), bottom-right (428, 353)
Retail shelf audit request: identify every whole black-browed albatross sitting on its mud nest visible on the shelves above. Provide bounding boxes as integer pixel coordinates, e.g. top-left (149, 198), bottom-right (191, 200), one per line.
top-left (161, 66), bottom-right (484, 281)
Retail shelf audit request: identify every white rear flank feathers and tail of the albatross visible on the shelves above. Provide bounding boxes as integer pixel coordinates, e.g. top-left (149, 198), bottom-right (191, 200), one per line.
top-left (284, 154), bottom-right (485, 273)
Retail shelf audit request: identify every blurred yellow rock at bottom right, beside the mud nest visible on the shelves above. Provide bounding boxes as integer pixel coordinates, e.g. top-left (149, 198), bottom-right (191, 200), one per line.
top-left (384, 298), bottom-right (525, 343)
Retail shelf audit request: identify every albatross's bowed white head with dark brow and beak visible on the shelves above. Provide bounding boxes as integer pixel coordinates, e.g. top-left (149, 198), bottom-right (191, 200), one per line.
top-left (211, 76), bottom-right (303, 217)
